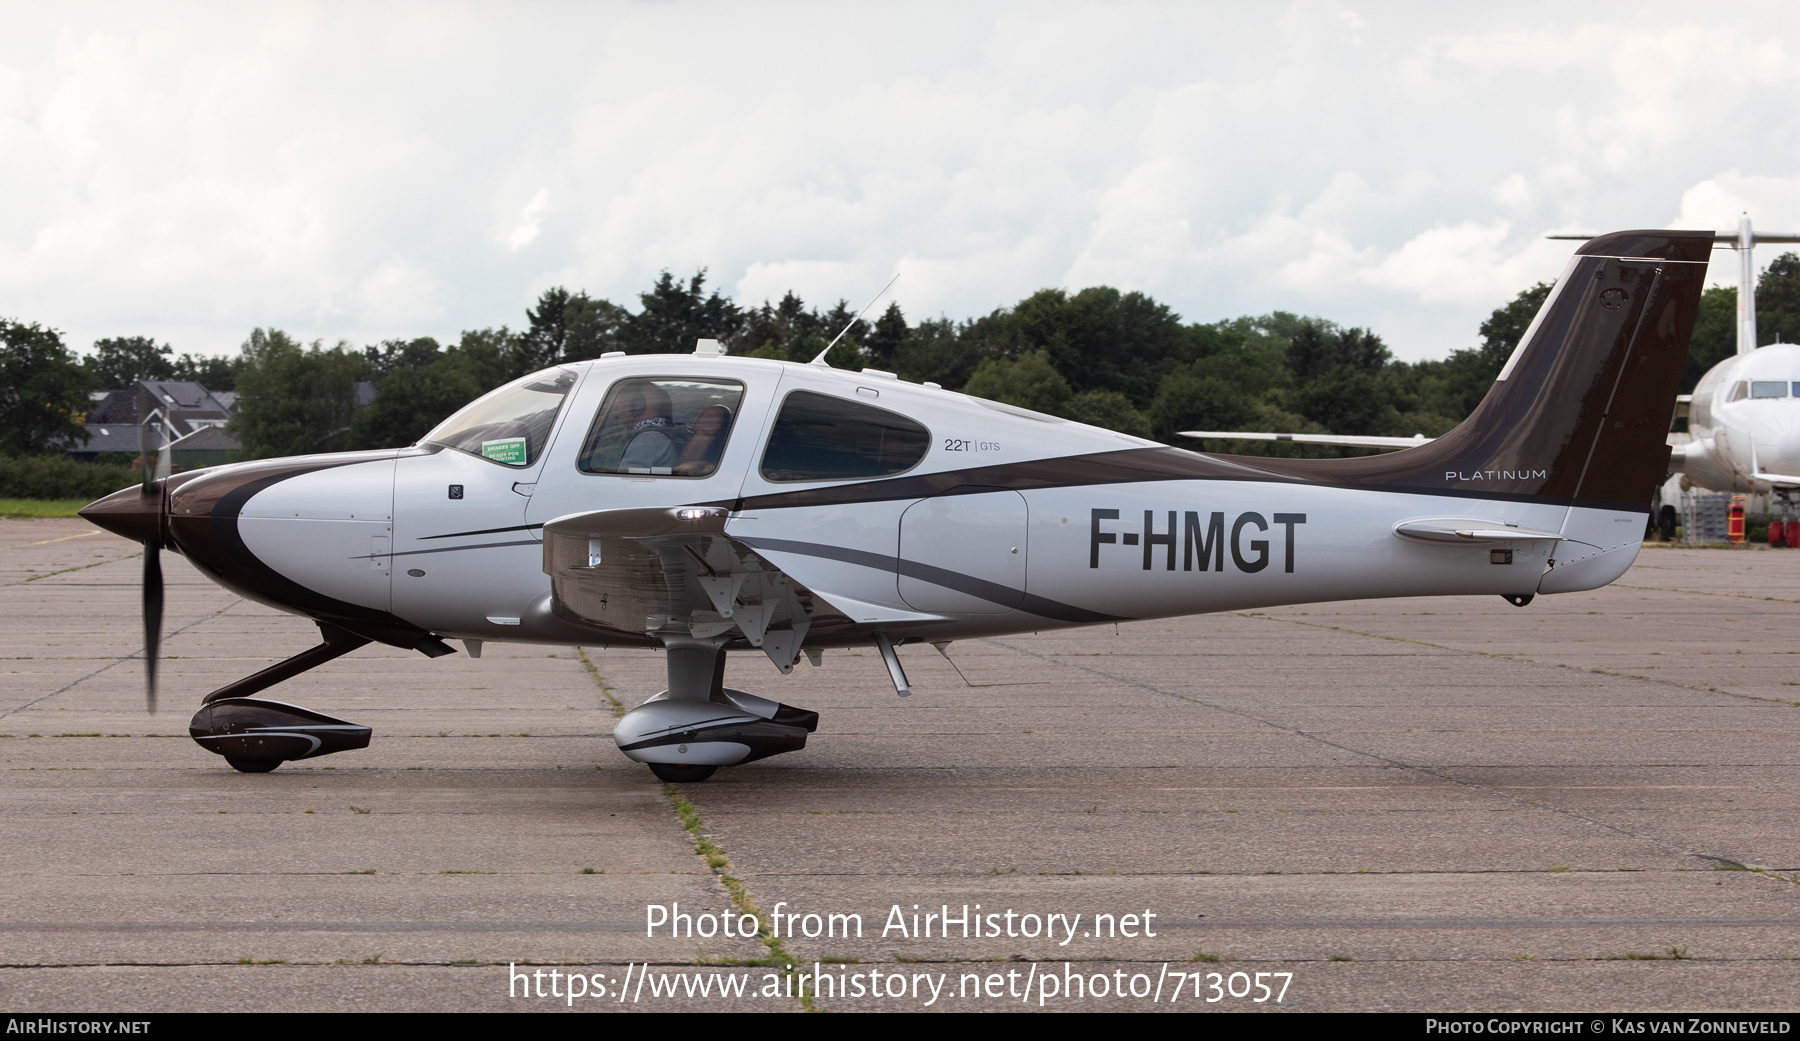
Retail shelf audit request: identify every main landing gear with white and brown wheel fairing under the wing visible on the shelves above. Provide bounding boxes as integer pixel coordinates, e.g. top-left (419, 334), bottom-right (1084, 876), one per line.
top-left (612, 639), bottom-right (819, 782)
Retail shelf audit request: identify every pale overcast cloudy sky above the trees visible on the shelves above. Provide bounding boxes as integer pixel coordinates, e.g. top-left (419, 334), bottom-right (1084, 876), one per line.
top-left (0, 0), bottom-right (1800, 358)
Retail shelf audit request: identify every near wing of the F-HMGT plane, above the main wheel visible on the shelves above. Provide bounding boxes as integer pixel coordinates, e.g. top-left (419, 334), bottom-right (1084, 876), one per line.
top-left (544, 506), bottom-right (850, 672)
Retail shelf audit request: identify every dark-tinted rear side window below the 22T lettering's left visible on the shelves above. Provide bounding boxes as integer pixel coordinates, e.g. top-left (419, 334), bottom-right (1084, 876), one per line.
top-left (761, 391), bottom-right (931, 481)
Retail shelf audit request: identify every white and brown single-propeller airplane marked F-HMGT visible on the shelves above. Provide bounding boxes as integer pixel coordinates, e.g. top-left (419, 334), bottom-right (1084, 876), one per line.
top-left (81, 231), bottom-right (1712, 780)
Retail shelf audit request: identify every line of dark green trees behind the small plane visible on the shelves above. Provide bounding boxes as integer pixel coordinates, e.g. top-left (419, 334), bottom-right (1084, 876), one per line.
top-left (0, 254), bottom-right (1800, 457)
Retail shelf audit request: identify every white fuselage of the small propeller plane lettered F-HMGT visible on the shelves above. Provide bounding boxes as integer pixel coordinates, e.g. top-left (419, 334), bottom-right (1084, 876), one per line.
top-left (214, 348), bottom-right (1648, 643)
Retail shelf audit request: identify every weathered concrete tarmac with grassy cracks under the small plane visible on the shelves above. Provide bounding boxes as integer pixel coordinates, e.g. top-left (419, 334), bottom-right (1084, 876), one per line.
top-left (0, 521), bottom-right (1800, 1012)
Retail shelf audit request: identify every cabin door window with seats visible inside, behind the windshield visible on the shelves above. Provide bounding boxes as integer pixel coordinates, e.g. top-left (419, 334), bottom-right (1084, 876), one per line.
top-left (580, 376), bottom-right (743, 477)
